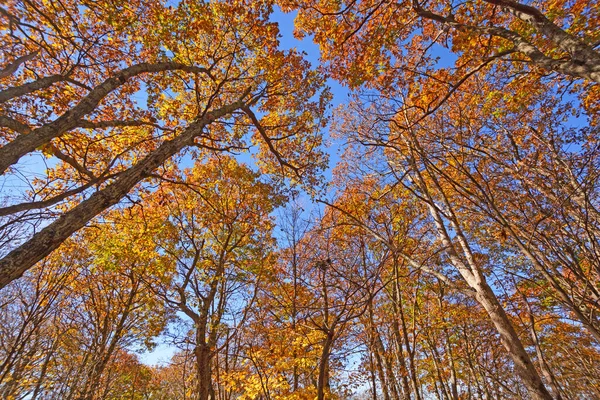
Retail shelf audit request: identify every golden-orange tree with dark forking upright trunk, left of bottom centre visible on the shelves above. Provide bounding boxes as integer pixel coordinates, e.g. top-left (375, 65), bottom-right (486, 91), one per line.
top-left (147, 156), bottom-right (281, 400)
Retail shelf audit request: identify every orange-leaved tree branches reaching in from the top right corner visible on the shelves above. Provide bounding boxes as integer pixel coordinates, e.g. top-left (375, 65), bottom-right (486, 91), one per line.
top-left (279, 0), bottom-right (600, 119)
